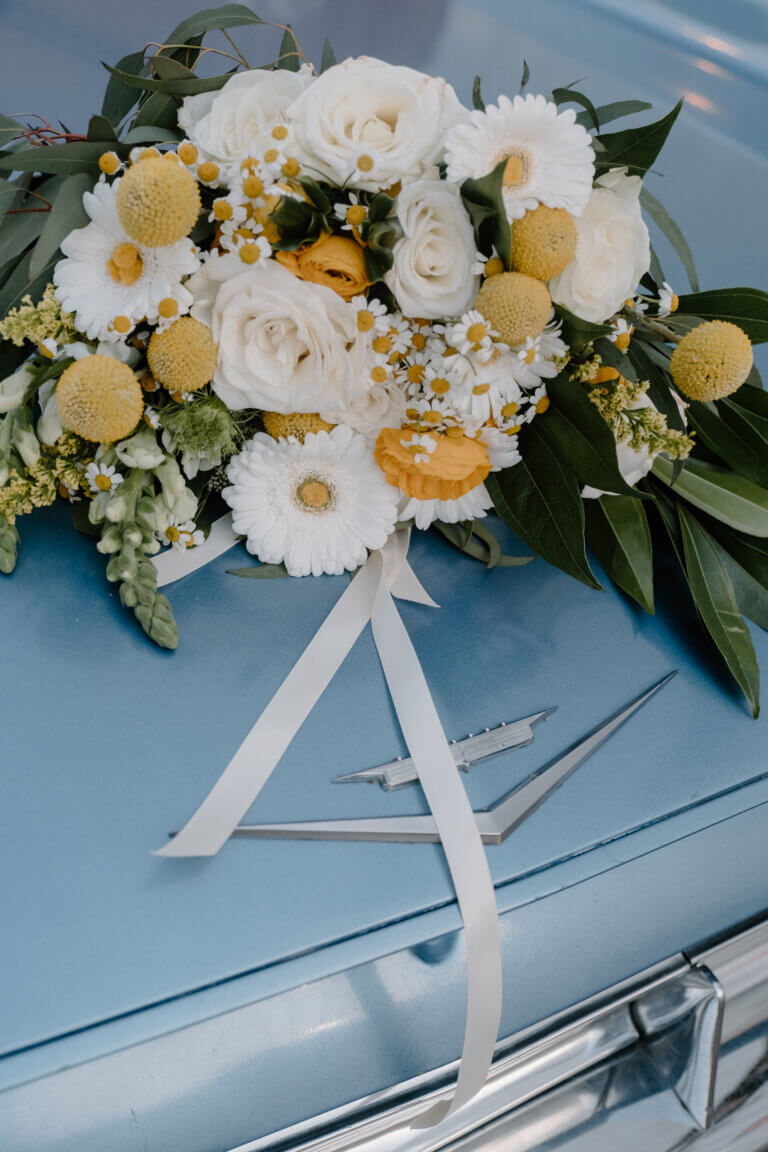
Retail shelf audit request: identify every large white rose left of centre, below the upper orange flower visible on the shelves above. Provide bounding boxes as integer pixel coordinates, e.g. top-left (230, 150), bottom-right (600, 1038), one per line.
top-left (188, 253), bottom-right (366, 412)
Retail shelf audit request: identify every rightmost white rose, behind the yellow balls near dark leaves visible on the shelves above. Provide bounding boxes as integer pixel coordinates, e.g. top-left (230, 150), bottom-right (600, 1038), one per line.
top-left (549, 168), bottom-right (651, 324)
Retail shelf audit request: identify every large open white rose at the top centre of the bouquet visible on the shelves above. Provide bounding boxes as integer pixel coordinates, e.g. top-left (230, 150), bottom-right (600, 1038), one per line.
top-left (289, 56), bottom-right (469, 191)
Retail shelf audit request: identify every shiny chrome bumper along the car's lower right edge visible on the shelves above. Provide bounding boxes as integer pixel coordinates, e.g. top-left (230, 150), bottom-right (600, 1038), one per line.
top-left (233, 919), bottom-right (768, 1152)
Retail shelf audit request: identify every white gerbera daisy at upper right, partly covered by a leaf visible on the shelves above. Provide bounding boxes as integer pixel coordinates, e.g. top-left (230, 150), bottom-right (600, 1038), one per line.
top-left (446, 96), bottom-right (594, 220)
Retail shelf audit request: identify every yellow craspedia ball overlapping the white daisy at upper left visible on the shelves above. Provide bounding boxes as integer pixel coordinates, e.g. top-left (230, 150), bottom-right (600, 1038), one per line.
top-left (115, 157), bottom-right (200, 248)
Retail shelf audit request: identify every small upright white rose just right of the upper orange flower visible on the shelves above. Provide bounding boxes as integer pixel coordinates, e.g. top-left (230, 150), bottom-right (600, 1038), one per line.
top-left (385, 180), bottom-right (479, 320)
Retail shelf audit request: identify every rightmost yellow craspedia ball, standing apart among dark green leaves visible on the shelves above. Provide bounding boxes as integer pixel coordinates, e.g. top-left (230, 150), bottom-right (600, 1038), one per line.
top-left (669, 320), bottom-right (752, 401)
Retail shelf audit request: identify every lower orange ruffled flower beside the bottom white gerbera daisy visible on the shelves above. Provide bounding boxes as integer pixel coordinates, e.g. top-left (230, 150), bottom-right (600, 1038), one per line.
top-left (373, 426), bottom-right (491, 500)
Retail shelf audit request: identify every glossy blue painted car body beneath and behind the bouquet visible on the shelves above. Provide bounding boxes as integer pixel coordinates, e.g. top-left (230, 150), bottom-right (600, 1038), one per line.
top-left (0, 0), bottom-right (768, 1152)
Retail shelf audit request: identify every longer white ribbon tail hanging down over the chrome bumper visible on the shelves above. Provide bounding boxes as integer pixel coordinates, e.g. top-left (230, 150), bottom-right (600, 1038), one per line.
top-left (372, 543), bottom-right (502, 1128)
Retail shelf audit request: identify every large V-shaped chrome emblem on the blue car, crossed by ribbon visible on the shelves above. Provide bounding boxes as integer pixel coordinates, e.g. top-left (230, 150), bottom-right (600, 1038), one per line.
top-left (215, 672), bottom-right (676, 844)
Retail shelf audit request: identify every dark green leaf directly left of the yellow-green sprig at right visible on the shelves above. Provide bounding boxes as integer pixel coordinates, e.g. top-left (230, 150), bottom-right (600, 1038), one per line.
top-left (542, 377), bottom-right (640, 499)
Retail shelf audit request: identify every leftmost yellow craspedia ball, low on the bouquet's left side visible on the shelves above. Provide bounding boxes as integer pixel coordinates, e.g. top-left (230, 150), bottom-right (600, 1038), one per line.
top-left (56, 355), bottom-right (144, 444)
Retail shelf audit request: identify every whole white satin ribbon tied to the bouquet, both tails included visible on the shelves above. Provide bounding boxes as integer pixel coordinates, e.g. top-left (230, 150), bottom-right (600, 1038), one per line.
top-left (157, 522), bottom-right (501, 1128)
